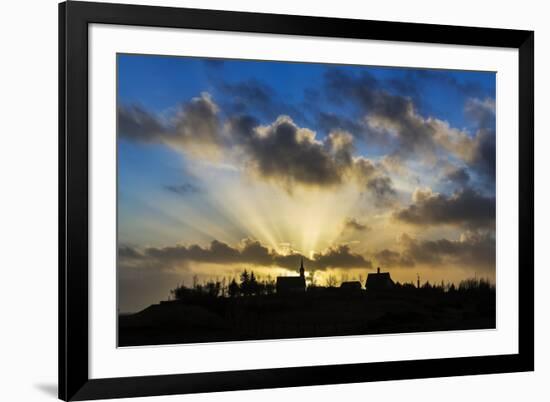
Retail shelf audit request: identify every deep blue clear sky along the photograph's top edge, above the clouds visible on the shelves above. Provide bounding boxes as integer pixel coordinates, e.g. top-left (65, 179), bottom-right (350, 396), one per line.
top-left (118, 55), bottom-right (496, 127)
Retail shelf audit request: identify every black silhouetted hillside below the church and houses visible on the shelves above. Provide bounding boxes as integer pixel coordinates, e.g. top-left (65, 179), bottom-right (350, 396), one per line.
top-left (118, 277), bottom-right (496, 346)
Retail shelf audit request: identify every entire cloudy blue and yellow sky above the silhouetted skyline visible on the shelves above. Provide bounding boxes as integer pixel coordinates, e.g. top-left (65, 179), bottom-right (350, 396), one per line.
top-left (117, 54), bottom-right (496, 311)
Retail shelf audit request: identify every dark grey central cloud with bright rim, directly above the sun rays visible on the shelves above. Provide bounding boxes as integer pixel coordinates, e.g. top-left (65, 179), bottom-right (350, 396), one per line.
top-left (228, 116), bottom-right (395, 200)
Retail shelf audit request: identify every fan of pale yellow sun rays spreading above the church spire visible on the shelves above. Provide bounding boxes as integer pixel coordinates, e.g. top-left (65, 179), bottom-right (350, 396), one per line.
top-left (158, 157), bottom-right (368, 257)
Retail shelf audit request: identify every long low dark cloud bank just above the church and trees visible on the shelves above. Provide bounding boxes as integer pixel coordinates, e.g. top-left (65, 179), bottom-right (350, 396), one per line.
top-left (119, 239), bottom-right (371, 270)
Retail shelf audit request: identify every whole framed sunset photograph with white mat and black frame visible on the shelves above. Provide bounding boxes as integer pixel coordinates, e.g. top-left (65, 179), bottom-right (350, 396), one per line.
top-left (59, 1), bottom-right (534, 400)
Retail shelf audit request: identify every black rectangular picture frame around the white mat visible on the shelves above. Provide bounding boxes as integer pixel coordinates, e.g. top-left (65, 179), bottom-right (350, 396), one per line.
top-left (59, 1), bottom-right (534, 400)
